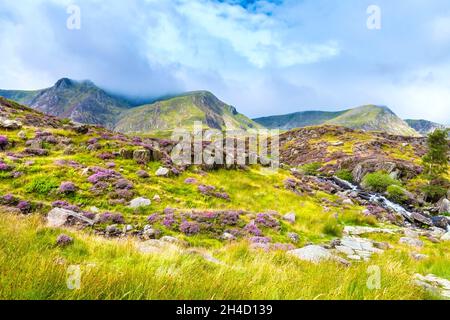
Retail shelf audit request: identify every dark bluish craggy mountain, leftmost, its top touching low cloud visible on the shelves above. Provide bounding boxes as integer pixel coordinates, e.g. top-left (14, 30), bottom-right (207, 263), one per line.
top-left (0, 78), bottom-right (130, 129)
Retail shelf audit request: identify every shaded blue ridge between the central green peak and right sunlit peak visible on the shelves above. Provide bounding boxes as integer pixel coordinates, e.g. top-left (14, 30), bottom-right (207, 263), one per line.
top-left (254, 111), bottom-right (345, 130)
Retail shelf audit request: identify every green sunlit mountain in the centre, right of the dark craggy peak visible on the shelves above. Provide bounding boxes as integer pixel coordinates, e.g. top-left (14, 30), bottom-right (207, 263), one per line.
top-left (115, 91), bottom-right (260, 133)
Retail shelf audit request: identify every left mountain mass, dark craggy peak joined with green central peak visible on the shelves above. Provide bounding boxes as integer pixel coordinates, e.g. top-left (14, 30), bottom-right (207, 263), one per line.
top-left (0, 78), bottom-right (260, 133)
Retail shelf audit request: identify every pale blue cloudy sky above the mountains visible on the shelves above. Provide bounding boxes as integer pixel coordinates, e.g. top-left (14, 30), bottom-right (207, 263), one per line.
top-left (0, 0), bottom-right (450, 124)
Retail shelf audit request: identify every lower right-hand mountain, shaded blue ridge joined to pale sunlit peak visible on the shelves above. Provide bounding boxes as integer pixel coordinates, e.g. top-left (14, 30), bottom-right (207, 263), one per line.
top-left (254, 105), bottom-right (419, 136)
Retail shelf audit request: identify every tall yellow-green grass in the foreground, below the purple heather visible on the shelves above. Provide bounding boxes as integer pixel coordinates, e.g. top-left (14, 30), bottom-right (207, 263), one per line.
top-left (0, 215), bottom-right (438, 299)
